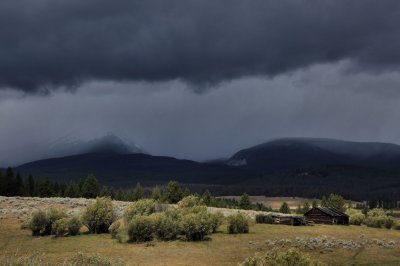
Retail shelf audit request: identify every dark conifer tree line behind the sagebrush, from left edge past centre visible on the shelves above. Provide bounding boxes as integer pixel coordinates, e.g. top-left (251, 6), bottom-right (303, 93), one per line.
top-left (0, 167), bottom-right (271, 211)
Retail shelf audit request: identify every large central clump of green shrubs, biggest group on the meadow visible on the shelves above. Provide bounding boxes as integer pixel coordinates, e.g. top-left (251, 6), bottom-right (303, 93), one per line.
top-left (117, 196), bottom-right (224, 243)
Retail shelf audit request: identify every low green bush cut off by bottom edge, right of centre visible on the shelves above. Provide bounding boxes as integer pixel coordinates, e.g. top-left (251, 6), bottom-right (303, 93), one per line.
top-left (239, 248), bottom-right (326, 266)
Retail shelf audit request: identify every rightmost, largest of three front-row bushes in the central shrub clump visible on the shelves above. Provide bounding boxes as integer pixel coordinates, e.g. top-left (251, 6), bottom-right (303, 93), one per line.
top-left (180, 211), bottom-right (213, 241)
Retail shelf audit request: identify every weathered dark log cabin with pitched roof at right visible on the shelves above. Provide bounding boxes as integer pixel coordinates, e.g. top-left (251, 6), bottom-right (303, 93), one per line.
top-left (304, 207), bottom-right (349, 225)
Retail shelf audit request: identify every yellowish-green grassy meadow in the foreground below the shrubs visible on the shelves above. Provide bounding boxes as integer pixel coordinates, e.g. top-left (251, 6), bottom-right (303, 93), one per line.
top-left (0, 218), bottom-right (400, 265)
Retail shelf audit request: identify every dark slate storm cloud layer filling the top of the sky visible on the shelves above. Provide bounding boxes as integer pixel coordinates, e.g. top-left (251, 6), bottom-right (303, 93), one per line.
top-left (0, 0), bottom-right (400, 91)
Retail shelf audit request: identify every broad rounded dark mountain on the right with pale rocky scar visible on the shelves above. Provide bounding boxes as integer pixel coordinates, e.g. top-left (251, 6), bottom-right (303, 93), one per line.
top-left (227, 138), bottom-right (400, 172)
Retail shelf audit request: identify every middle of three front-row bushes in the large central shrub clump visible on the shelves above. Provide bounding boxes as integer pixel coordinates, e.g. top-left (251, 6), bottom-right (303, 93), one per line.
top-left (153, 214), bottom-right (179, 241)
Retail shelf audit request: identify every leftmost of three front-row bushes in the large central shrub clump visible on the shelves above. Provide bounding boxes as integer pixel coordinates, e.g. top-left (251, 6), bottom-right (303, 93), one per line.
top-left (127, 216), bottom-right (154, 243)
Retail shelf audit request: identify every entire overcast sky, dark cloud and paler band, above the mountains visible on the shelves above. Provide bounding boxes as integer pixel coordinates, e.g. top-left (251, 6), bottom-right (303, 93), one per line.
top-left (0, 0), bottom-right (400, 166)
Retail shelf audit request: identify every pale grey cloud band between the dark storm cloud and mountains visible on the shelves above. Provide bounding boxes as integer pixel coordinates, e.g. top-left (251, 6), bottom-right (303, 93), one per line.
top-left (0, 62), bottom-right (400, 166)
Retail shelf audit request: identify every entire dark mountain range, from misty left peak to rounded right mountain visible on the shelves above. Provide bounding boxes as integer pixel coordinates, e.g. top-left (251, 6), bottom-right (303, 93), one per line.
top-left (2, 136), bottom-right (400, 199)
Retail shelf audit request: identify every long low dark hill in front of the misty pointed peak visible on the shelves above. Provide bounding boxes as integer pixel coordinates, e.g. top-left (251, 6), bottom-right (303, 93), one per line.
top-left (16, 153), bottom-right (250, 185)
